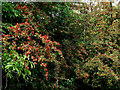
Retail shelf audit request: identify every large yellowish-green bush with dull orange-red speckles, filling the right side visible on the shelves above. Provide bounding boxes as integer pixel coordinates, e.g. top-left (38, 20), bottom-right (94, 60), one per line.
top-left (72, 2), bottom-right (120, 89)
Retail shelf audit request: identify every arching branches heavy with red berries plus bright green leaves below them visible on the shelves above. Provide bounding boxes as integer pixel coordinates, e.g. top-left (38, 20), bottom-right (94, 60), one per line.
top-left (2, 22), bottom-right (64, 84)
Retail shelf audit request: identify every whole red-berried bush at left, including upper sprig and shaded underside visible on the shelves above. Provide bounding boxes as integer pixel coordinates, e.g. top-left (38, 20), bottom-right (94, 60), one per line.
top-left (2, 2), bottom-right (68, 88)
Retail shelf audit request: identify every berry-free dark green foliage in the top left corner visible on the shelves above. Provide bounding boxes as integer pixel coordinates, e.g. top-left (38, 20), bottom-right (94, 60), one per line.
top-left (2, 2), bottom-right (23, 25)
